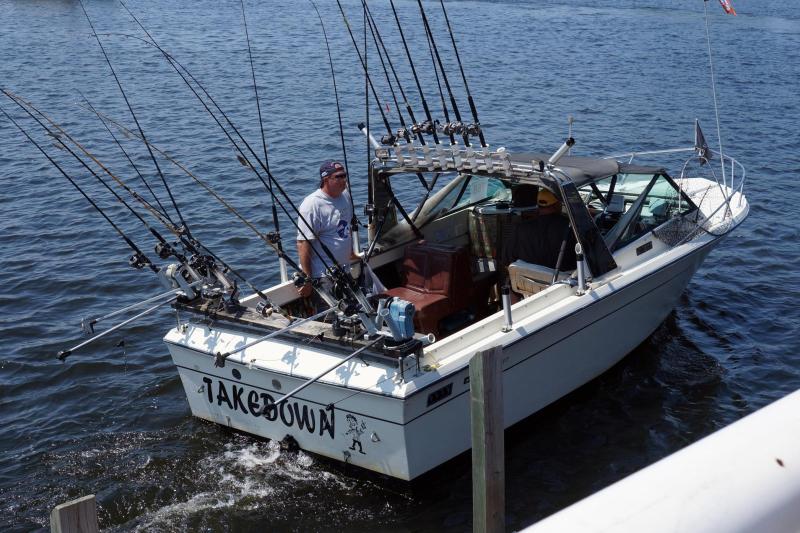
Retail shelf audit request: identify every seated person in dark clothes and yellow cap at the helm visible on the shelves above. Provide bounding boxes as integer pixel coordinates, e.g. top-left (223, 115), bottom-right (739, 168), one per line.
top-left (501, 188), bottom-right (576, 272)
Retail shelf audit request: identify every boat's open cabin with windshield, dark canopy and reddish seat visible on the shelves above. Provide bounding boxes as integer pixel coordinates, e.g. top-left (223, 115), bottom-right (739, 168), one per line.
top-left (365, 147), bottom-right (697, 338)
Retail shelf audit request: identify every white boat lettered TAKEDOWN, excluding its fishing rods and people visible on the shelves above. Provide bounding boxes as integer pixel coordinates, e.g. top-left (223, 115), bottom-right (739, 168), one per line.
top-left (164, 139), bottom-right (749, 480)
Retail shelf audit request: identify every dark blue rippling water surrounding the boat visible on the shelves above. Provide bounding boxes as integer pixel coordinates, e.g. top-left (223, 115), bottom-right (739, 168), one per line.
top-left (0, 0), bottom-right (800, 531)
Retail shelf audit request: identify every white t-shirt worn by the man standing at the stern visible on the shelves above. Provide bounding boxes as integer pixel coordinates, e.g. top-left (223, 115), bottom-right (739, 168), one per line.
top-left (297, 189), bottom-right (353, 278)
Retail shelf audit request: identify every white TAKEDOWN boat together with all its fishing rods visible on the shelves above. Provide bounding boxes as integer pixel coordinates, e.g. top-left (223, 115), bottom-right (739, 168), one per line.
top-left (0, 2), bottom-right (749, 480)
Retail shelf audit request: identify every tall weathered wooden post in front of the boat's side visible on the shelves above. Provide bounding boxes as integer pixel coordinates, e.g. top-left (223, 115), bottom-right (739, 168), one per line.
top-left (469, 346), bottom-right (506, 533)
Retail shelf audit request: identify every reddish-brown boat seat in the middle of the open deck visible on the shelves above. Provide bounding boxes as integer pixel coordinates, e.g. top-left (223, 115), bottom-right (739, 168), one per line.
top-left (386, 243), bottom-right (472, 336)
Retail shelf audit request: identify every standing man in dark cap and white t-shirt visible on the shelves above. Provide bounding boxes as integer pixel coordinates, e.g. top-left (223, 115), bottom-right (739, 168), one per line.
top-left (297, 161), bottom-right (358, 298)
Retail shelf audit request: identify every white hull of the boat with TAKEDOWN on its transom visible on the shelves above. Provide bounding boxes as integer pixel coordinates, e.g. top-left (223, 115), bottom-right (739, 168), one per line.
top-left (165, 239), bottom-right (719, 480)
